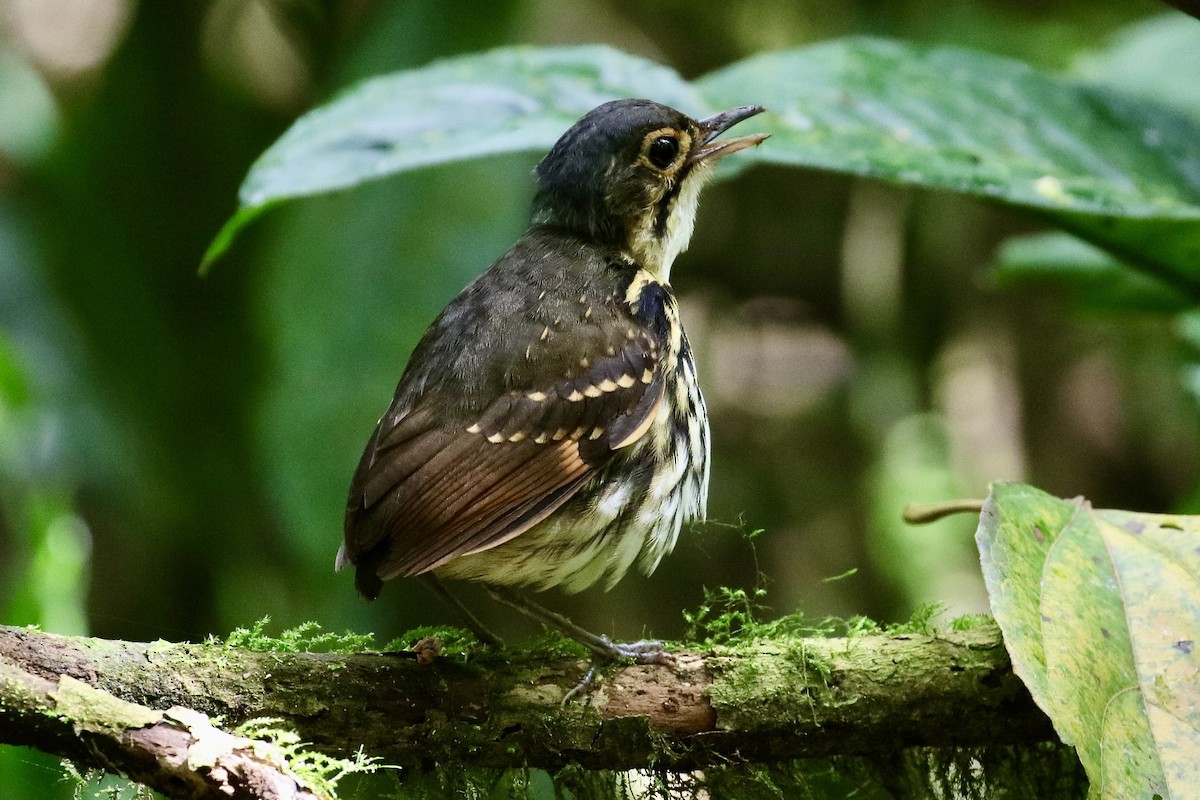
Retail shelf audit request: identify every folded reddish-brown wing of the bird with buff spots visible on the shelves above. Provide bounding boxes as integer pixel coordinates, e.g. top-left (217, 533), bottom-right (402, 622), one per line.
top-left (344, 332), bottom-right (664, 594)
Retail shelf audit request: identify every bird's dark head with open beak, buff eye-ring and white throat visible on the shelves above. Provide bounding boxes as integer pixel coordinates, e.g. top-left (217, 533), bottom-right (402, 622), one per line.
top-left (534, 100), bottom-right (767, 281)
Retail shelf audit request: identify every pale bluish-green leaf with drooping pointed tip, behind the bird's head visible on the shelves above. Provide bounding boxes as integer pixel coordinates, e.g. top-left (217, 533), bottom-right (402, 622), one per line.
top-left (204, 47), bottom-right (704, 264)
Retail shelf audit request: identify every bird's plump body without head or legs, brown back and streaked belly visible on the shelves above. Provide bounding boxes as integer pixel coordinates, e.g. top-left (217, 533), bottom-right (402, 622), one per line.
top-left (342, 225), bottom-right (708, 596)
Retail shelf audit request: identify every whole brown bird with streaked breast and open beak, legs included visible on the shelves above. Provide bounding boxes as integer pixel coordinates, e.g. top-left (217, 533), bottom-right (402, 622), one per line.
top-left (335, 100), bottom-right (767, 662)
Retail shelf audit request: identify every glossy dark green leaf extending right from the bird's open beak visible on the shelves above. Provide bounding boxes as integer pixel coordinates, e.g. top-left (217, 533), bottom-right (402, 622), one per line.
top-left (697, 38), bottom-right (1200, 295)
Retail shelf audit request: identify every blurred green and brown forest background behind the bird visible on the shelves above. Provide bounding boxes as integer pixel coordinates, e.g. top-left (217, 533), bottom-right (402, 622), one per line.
top-left (0, 0), bottom-right (1200, 796)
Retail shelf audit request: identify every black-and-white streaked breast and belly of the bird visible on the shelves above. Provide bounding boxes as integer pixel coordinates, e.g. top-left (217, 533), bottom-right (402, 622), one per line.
top-left (427, 270), bottom-right (709, 591)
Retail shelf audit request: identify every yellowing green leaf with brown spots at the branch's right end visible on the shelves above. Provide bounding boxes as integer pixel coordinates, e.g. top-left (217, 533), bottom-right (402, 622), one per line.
top-left (976, 483), bottom-right (1200, 798)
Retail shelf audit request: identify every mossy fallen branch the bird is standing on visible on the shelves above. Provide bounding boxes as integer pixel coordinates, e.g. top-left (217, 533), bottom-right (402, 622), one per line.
top-left (0, 626), bottom-right (1054, 796)
